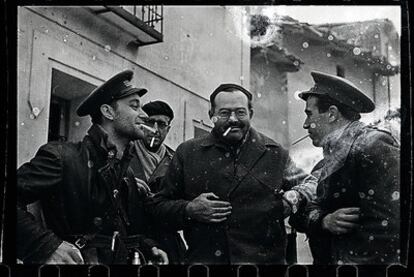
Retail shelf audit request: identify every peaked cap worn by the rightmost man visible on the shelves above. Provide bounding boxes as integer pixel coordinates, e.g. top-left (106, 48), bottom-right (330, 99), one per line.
top-left (299, 71), bottom-right (375, 113)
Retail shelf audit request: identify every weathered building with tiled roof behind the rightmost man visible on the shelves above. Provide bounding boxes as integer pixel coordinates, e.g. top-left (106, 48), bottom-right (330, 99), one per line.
top-left (247, 14), bottom-right (401, 171)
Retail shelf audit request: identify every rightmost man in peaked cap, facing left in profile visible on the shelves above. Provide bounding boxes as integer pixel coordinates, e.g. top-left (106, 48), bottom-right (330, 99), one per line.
top-left (292, 72), bottom-right (400, 264)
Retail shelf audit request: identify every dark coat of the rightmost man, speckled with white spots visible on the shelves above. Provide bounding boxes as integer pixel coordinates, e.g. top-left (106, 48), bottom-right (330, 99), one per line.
top-left (292, 121), bottom-right (401, 264)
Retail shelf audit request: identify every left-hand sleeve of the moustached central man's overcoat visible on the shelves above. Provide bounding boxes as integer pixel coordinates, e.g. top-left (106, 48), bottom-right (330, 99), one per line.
top-left (146, 143), bottom-right (190, 230)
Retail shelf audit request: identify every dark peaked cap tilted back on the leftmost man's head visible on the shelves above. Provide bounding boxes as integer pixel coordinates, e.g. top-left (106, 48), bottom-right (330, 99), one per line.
top-left (76, 70), bottom-right (147, 116)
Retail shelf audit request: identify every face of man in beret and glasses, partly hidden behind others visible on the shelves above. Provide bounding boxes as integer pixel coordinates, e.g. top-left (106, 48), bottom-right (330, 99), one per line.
top-left (142, 115), bottom-right (170, 151)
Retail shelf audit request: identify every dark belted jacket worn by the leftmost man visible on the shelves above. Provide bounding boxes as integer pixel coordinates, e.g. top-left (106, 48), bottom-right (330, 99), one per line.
top-left (17, 125), bottom-right (156, 263)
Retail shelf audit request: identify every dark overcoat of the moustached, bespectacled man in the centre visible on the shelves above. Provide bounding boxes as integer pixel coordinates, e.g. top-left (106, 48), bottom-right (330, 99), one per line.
top-left (150, 128), bottom-right (314, 264)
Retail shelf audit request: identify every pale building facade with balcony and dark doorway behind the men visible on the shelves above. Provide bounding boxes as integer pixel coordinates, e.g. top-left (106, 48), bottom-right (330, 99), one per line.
top-left (17, 6), bottom-right (250, 166)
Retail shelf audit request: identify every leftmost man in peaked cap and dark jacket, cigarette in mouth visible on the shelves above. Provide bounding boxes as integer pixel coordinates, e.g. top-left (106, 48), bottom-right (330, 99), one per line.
top-left (17, 70), bottom-right (168, 264)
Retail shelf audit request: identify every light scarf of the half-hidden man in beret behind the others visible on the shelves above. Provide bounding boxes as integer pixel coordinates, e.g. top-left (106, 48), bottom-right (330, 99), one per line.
top-left (134, 140), bottom-right (167, 181)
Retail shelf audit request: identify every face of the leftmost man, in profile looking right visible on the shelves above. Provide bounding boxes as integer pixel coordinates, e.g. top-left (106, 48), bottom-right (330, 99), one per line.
top-left (113, 94), bottom-right (147, 140)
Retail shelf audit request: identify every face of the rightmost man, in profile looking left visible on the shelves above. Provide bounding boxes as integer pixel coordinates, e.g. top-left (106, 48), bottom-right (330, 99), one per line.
top-left (303, 96), bottom-right (331, 147)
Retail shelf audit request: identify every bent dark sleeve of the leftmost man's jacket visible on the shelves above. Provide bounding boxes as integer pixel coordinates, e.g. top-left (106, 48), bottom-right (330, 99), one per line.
top-left (16, 144), bottom-right (62, 263)
